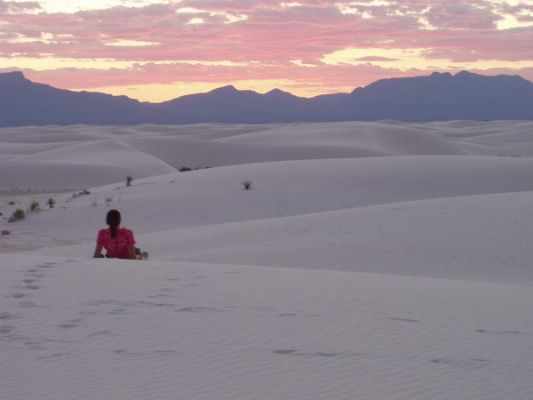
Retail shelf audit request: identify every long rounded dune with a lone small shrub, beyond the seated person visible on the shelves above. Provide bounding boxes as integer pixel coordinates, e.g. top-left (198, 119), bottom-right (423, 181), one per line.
top-left (5, 156), bottom-right (533, 234)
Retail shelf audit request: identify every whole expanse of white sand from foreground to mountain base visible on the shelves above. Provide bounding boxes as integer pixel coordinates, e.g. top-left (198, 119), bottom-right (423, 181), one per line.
top-left (0, 121), bottom-right (533, 400)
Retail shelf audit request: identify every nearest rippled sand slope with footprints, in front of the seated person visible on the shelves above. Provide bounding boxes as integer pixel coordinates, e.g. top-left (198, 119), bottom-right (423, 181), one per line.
top-left (0, 256), bottom-right (533, 400)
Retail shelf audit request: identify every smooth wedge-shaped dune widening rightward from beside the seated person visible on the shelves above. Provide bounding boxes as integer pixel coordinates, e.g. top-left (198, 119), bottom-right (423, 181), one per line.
top-left (31, 192), bottom-right (533, 285)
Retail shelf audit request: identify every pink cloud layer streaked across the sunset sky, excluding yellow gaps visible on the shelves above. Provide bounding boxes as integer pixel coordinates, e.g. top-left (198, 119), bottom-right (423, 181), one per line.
top-left (0, 0), bottom-right (533, 97)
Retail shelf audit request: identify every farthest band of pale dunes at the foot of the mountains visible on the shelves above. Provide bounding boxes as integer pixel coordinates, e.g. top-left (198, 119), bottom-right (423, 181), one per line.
top-left (4, 121), bottom-right (533, 189)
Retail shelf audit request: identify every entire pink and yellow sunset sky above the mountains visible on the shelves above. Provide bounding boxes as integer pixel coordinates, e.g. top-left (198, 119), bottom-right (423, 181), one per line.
top-left (0, 0), bottom-right (533, 102)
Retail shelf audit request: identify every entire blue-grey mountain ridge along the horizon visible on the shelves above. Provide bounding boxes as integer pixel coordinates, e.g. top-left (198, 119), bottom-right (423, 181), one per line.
top-left (0, 71), bottom-right (533, 127)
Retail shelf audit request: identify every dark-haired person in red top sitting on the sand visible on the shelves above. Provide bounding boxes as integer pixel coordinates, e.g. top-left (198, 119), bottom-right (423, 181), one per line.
top-left (93, 210), bottom-right (148, 260)
